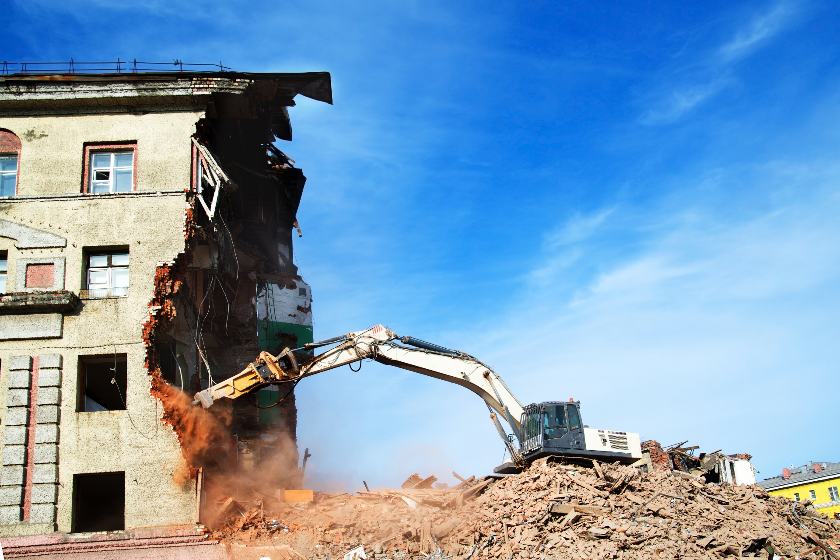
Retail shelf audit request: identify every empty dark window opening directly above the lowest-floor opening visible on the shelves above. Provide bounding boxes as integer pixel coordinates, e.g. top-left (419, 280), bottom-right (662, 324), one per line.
top-left (76, 354), bottom-right (127, 412)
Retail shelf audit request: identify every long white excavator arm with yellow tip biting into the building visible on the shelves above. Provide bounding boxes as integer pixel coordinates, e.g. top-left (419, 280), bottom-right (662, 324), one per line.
top-left (194, 325), bottom-right (523, 461)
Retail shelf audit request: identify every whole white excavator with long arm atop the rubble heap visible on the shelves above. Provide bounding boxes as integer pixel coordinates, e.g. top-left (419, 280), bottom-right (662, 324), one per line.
top-left (193, 325), bottom-right (642, 473)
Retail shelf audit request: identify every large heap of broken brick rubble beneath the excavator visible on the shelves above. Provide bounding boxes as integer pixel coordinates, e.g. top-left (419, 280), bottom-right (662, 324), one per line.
top-left (217, 460), bottom-right (840, 558)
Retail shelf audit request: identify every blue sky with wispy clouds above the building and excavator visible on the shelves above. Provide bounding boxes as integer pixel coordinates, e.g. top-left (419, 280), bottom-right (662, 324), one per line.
top-left (0, 0), bottom-right (840, 488)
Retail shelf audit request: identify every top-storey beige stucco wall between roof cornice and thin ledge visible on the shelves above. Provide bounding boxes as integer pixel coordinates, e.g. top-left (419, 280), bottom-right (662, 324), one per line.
top-left (0, 112), bottom-right (201, 196)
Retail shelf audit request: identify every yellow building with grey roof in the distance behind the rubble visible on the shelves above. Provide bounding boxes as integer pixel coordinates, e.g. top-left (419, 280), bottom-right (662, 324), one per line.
top-left (758, 463), bottom-right (840, 519)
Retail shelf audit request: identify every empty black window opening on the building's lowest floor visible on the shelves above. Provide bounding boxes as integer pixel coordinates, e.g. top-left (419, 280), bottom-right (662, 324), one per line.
top-left (71, 472), bottom-right (125, 533)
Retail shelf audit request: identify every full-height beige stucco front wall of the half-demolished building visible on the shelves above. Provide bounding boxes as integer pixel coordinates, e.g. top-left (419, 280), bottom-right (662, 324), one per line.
top-left (0, 109), bottom-right (199, 534)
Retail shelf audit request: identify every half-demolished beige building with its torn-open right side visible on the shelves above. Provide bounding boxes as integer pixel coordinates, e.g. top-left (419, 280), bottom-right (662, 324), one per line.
top-left (0, 71), bottom-right (332, 535)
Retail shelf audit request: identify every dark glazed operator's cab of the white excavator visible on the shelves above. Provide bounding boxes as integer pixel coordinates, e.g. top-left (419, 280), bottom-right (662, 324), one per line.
top-left (521, 401), bottom-right (586, 461)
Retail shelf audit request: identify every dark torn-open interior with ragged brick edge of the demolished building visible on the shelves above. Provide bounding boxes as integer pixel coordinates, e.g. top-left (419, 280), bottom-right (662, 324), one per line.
top-left (143, 91), bottom-right (312, 512)
